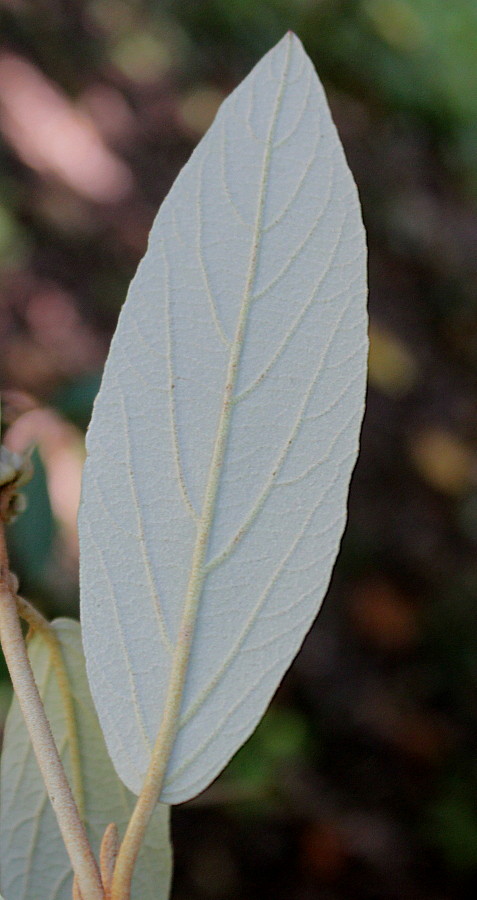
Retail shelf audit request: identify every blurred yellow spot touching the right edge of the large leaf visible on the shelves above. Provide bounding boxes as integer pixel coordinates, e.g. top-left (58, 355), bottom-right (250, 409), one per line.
top-left (368, 325), bottom-right (417, 397)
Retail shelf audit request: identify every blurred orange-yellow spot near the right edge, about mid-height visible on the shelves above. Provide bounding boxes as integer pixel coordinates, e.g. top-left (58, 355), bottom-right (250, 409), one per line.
top-left (410, 428), bottom-right (476, 495)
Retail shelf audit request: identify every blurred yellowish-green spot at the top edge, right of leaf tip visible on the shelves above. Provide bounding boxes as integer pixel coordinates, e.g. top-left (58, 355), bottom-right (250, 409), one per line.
top-left (363, 0), bottom-right (425, 50)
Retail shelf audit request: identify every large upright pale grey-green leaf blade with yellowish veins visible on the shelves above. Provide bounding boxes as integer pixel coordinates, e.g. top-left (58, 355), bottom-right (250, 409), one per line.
top-left (80, 34), bottom-right (367, 803)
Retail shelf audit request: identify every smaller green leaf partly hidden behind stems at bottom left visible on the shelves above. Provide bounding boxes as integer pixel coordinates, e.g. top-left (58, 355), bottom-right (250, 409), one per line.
top-left (0, 619), bottom-right (171, 900)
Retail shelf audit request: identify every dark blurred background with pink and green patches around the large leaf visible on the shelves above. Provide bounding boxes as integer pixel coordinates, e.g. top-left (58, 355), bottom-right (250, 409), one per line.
top-left (0, 0), bottom-right (477, 900)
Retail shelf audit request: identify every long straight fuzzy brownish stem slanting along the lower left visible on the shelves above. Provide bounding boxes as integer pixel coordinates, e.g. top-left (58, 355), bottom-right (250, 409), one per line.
top-left (0, 512), bottom-right (104, 900)
